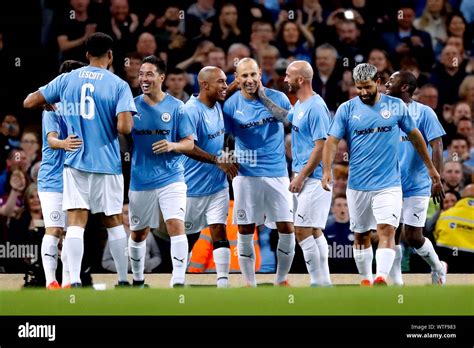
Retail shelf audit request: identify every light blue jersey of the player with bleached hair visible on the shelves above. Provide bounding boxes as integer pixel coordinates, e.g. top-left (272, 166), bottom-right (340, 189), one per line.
top-left (328, 94), bottom-right (416, 191)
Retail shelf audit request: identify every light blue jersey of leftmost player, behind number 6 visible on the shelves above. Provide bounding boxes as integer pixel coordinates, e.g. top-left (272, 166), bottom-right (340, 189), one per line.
top-left (38, 111), bottom-right (67, 193)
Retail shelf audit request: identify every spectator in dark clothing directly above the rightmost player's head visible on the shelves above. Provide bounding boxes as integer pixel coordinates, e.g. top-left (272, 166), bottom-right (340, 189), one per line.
top-left (382, 7), bottom-right (434, 71)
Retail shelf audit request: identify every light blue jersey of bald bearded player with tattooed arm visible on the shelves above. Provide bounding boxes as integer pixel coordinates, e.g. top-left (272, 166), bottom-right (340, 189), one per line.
top-left (288, 94), bottom-right (330, 180)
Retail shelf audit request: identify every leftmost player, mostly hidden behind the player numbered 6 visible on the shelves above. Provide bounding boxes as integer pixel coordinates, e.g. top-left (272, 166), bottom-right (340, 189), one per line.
top-left (38, 60), bottom-right (85, 289)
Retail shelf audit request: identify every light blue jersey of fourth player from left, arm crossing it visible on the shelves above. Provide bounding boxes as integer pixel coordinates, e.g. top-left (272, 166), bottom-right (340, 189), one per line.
top-left (184, 96), bottom-right (229, 197)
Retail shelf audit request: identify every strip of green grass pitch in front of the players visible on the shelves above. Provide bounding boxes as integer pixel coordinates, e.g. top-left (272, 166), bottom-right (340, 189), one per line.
top-left (0, 285), bottom-right (474, 316)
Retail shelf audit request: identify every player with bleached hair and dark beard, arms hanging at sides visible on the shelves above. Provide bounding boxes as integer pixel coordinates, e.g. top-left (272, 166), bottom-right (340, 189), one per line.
top-left (322, 63), bottom-right (440, 285)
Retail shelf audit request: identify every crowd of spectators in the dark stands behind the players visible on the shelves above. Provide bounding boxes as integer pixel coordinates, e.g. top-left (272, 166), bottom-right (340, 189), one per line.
top-left (0, 0), bottom-right (474, 286)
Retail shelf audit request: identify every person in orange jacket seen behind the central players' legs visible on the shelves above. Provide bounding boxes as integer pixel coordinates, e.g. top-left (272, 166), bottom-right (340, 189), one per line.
top-left (187, 200), bottom-right (261, 273)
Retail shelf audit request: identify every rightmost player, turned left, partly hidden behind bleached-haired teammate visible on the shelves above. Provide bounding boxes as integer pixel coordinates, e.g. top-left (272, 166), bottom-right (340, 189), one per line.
top-left (385, 71), bottom-right (447, 285)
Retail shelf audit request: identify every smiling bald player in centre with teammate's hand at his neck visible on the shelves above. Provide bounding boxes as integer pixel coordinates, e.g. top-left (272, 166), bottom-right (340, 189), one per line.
top-left (224, 58), bottom-right (295, 287)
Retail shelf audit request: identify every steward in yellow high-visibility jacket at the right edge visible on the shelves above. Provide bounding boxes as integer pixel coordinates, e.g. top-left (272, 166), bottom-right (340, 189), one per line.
top-left (434, 184), bottom-right (474, 273)
